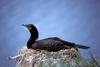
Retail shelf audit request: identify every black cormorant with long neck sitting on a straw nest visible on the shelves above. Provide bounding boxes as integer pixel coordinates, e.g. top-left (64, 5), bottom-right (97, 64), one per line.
top-left (22, 24), bottom-right (90, 52)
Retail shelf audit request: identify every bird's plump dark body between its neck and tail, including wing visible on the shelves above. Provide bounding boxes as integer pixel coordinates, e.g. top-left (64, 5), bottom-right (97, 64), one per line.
top-left (32, 37), bottom-right (74, 51)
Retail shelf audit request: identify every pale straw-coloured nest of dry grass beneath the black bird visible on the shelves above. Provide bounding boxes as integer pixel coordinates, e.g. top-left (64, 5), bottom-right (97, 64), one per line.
top-left (9, 47), bottom-right (80, 67)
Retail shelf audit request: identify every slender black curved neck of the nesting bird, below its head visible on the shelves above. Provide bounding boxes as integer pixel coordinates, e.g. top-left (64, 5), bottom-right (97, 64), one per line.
top-left (27, 30), bottom-right (38, 48)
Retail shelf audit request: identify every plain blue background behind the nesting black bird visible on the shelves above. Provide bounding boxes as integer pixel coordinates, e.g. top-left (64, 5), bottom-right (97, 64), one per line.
top-left (0, 0), bottom-right (100, 67)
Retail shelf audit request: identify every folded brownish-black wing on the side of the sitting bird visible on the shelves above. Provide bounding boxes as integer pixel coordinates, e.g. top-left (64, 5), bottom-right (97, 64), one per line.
top-left (32, 38), bottom-right (63, 50)
